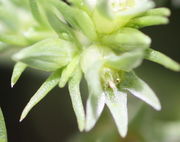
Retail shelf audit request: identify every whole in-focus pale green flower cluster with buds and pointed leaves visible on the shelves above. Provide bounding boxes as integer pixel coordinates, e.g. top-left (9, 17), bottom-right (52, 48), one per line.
top-left (0, 0), bottom-right (180, 137)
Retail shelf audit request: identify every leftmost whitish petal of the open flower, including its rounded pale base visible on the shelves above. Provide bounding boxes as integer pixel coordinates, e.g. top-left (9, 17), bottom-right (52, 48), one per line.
top-left (81, 46), bottom-right (105, 131)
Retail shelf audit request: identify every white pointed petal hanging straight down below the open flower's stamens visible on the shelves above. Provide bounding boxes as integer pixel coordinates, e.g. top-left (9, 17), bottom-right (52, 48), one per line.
top-left (106, 90), bottom-right (128, 137)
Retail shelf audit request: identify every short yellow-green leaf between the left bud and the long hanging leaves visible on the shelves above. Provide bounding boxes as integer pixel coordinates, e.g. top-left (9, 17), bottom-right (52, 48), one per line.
top-left (59, 56), bottom-right (79, 88)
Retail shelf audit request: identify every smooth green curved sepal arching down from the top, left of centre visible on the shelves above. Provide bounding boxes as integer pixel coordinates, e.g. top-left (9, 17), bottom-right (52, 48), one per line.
top-left (56, 1), bottom-right (97, 40)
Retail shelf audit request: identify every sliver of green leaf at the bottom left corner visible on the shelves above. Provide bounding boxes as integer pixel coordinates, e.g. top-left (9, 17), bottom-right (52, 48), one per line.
top-left (0, 108), bottom-right (7, 142)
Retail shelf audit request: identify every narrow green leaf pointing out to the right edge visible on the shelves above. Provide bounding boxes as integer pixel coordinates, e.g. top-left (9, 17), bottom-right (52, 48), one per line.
top-left (145, 49), bottom-right (180, 71)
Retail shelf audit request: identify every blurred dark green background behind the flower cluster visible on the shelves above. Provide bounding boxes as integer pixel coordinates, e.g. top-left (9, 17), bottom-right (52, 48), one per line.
top-left (0, 0), bottom-right (180, 142)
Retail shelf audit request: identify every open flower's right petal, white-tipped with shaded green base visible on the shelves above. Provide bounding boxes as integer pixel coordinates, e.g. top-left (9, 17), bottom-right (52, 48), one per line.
top-left (120, 72), bottom-right (161, 110)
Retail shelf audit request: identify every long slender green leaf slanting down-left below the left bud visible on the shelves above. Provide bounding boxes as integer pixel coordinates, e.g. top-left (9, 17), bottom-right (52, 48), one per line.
top-left (20, 70), bottom-right (61, 121)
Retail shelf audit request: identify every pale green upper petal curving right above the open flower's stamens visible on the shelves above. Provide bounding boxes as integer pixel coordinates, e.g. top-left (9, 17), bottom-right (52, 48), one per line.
top-left (105, 50), bottom-right (144, 71)
